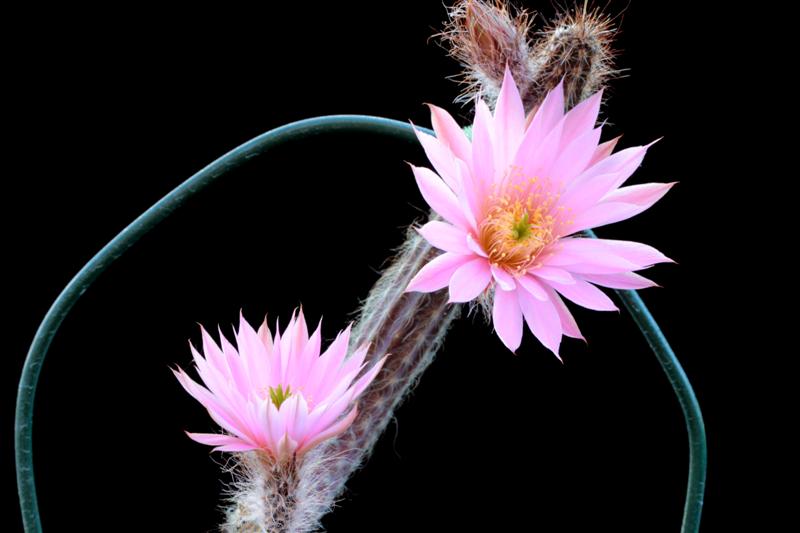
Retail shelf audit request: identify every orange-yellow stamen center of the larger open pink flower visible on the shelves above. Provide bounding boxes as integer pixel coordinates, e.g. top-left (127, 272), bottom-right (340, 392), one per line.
top-left (478, 194), bottom-right (556, 276)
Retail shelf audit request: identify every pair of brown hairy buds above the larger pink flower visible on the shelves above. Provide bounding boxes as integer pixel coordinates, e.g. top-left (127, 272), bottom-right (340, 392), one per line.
top-left (439, 0), bottom-right (616, 111)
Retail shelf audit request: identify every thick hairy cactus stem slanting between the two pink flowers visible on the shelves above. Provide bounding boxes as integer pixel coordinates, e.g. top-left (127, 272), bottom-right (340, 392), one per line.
top-left (290, 223), bottom-right (460, 518)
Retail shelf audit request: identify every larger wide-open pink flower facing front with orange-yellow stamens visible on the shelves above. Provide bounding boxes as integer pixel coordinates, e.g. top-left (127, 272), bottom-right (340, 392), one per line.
top-left (407, 69), bottom-right (674, 357)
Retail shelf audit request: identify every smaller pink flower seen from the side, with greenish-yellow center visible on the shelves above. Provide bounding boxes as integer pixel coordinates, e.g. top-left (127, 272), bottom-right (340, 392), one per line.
top-left (173, 310), bottom-right (385, 461)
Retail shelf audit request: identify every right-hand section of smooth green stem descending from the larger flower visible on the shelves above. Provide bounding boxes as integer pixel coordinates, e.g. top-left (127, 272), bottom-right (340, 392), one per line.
top-left (585, 230), bottom-right (708, 533)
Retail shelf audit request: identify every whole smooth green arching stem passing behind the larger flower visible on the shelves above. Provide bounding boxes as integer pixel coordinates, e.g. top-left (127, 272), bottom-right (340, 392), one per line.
top-left (14, 115), bottom-right (706, 533)
